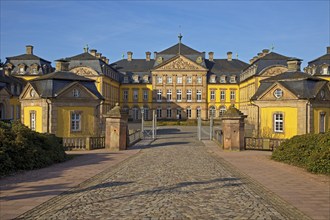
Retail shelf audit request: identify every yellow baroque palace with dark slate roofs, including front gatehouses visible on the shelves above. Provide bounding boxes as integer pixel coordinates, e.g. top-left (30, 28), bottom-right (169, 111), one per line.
top-left (0, 38), bottom-right (330, 138)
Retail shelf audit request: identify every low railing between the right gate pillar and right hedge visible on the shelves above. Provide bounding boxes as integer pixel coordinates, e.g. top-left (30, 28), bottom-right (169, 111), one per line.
top-left (244, 137), bottom-right (285, 151)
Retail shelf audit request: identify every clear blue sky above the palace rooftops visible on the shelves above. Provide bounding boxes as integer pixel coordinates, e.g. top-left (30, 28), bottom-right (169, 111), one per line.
top-left (0, 0), bottom-right (330, 66)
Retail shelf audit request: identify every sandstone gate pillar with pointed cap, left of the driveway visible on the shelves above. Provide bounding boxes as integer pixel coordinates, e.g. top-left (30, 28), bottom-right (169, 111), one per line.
top-left (105, 103), bottom-right (128, 151)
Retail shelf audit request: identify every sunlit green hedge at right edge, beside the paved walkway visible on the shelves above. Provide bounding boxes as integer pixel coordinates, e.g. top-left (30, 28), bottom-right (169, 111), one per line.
top-left (272, 131), bottom-right (330, 175)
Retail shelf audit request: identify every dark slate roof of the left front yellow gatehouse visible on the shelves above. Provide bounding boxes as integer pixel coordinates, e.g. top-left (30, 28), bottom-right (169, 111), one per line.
top-left (29, 71), bottom-right (104, 100)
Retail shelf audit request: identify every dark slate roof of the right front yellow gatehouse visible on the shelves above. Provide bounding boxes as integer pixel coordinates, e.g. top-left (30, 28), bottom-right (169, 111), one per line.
top-left (251, 71), bottom-right (328, 100)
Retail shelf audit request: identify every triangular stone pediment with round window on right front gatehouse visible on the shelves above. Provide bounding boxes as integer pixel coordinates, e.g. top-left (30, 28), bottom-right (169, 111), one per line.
top-left (258, 83), bottom-right (298, 101)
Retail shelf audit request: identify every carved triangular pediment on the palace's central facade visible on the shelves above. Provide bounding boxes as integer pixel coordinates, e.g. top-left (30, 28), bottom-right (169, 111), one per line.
top-left (155, 55), bottom-right (207, 71)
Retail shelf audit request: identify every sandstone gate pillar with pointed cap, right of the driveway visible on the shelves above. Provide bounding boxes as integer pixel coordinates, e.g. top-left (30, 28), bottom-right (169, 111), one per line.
top-left (222, 106), bottom-right (247, 151)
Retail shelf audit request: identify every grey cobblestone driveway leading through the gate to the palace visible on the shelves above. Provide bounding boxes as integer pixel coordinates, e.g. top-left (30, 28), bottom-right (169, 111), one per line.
top-left (16, 126), bottom-right (307, 219)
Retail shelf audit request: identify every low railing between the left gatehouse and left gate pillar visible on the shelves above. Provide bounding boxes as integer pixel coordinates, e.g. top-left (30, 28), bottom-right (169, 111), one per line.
top-left (63, 137), bottom-right (105, 150)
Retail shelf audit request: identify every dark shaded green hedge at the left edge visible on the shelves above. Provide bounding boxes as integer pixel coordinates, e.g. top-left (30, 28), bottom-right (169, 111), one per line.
top-left (0, 122), bottom-right (67, 176)
